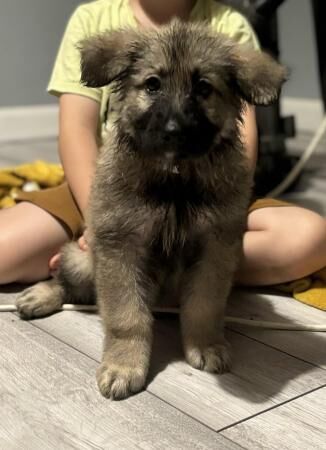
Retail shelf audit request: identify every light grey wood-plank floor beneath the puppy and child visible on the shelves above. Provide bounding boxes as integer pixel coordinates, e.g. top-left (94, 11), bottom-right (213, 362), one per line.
top-left (0, 136), bottom-right (326, 450)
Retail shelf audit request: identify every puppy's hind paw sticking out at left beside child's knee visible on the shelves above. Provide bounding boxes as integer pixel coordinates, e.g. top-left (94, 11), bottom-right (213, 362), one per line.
top-left (16, 280), bottom-right (63, 320)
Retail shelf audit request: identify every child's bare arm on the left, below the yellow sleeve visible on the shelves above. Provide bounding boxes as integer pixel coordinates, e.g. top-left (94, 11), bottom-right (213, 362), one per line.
top-left (59, 94), bottom-right (100, 215)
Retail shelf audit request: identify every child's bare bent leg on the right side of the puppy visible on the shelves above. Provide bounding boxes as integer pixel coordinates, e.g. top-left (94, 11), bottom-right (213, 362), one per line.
top-left (236, 206), bottom-right (326, 285)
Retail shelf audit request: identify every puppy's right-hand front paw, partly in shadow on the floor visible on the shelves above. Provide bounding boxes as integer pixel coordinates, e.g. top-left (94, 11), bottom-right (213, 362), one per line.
top-left (186, 342), bottom-right (231, 373)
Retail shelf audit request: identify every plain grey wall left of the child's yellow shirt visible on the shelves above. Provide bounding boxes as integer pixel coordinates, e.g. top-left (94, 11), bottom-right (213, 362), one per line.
top-left (0, 0), bottom-right (81, 107)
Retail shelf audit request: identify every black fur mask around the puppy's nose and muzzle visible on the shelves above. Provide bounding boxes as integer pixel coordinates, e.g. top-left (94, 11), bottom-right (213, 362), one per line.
top-left (130, 79), bottom-right (219, 159)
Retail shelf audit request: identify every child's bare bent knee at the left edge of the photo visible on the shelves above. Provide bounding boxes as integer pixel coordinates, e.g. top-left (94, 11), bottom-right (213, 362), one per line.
top-left (0, 202), bottom-right (69, 284)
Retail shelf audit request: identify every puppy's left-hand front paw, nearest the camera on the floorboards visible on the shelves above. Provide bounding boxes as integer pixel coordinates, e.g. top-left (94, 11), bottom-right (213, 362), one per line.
top-left (96, 362), bottom-right (146, 400)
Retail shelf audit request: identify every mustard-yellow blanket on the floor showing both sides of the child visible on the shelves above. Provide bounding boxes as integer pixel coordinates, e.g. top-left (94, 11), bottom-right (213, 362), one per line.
top-left (0, 161), bottom-right (326, 311)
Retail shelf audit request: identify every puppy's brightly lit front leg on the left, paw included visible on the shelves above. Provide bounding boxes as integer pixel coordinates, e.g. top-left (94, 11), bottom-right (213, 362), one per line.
top-left (95, 250), bottom-right (154, 399)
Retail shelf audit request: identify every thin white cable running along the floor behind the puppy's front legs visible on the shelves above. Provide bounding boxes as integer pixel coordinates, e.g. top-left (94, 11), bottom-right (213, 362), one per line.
top-left (0, 304), bottom-right (326, 331)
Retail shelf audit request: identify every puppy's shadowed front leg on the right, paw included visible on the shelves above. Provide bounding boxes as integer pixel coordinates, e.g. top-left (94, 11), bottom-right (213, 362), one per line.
top-left (180, 238), bottom-right (238, 373)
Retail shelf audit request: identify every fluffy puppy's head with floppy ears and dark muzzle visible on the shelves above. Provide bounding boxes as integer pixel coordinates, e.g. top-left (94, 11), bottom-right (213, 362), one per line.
top-left (81, 21), bottom-right (286, 159)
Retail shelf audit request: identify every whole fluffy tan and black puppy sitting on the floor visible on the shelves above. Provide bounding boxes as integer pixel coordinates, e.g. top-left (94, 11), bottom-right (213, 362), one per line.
top-left (17, 21), bottom-right (286, 399)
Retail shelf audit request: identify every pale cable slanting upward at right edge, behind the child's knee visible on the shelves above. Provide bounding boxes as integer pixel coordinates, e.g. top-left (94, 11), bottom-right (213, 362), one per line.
top-left (266, 116), bottom-right (326, 197)
